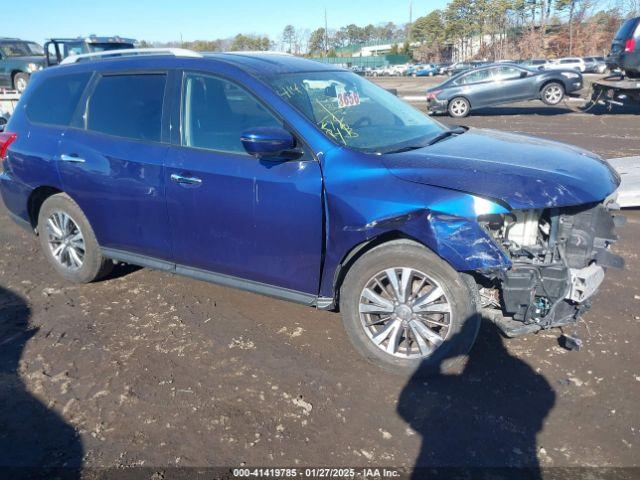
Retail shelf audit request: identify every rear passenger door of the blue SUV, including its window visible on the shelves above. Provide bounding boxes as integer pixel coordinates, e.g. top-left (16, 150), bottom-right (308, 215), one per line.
top-left (57, 71), bottom-right (171, 260)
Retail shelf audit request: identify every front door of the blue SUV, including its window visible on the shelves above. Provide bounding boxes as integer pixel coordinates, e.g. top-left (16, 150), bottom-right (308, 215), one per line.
top-left (165, 73), bottom-right (323, 294)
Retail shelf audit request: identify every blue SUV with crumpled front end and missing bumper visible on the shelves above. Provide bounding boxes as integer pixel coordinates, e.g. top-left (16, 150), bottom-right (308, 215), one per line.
top-left (0, 51), bottom-right (622, 374)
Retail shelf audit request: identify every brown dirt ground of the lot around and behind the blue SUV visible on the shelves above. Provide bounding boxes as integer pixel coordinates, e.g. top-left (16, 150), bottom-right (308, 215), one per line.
top-left (0, 79), bottom-right (640, 476)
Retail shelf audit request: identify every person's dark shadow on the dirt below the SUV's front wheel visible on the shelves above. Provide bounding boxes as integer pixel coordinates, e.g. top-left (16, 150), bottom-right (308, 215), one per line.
top-left (398, 316), bottom-right (556, 479)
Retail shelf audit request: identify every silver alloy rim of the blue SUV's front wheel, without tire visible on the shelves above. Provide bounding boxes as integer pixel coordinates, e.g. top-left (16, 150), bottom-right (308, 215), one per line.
top-left (358, 267), bottom-right (452, 358)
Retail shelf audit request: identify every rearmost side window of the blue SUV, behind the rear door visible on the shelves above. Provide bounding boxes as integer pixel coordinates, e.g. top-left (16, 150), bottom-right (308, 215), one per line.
top-left (26, 73), bottom-right (91, 126)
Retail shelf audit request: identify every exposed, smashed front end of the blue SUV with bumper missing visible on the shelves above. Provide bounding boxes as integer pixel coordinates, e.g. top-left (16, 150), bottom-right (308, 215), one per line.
top-left (476, 203), bottom-right (625, 336)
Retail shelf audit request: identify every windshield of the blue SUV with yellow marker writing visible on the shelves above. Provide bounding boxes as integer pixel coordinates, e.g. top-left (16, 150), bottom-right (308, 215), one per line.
top-left (268, 72), bottom-right (446, 153)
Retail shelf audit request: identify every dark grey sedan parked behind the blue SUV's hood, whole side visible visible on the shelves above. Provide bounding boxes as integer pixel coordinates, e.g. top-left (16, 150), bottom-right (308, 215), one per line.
top-left (427, 64), bottom-right (582, 117)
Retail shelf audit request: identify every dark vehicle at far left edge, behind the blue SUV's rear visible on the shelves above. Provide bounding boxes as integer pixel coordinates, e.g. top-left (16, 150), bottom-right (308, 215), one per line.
top-left (0, 38), bottom-right (44, 93)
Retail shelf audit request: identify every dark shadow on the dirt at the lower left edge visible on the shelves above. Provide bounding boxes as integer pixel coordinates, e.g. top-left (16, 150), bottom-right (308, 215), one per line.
top-left (0, 287), bottom-right (83, 479)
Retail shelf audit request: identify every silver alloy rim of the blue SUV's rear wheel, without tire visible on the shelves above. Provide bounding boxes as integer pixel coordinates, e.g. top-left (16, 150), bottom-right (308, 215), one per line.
top-left (47, 212), bottom-right (85, 270)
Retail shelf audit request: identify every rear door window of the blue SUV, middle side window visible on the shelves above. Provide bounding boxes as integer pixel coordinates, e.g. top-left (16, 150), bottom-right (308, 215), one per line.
top-left (87, 74), bottom-right (167, 142)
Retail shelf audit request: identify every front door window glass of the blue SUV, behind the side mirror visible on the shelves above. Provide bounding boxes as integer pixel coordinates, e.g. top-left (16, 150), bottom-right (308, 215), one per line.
top-left (182, 74), bottom-right (282, 154)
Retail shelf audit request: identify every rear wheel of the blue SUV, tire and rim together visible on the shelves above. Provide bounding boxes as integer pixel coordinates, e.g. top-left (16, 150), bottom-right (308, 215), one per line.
top-left (38, 193), bottom-right (113, 283)
